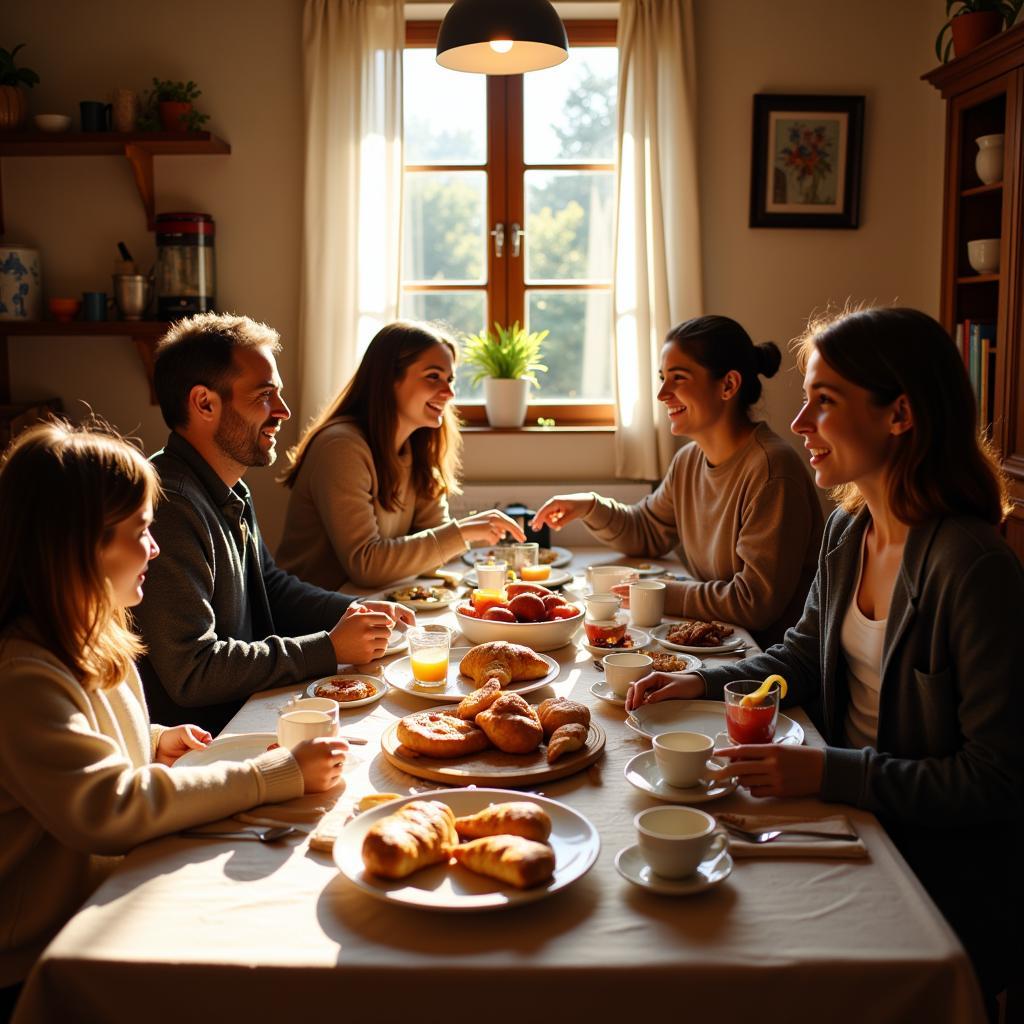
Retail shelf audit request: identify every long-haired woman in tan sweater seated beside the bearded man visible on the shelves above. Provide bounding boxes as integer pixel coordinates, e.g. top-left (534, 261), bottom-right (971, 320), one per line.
top-left (278, 322), bottom-right (524, 590)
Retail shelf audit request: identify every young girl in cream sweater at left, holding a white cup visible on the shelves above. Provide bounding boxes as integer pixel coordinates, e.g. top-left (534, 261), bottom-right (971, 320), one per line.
top-left (0, 423), bottom-right (346, 1020)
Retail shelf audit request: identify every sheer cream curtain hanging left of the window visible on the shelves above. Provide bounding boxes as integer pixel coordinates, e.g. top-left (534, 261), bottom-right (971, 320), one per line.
top-left (298, 0), bottom-right (406, 422)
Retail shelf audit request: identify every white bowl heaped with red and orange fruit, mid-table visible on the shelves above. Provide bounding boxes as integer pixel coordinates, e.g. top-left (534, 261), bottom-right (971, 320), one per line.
top-left (455, 583), bottom-right (584, 650)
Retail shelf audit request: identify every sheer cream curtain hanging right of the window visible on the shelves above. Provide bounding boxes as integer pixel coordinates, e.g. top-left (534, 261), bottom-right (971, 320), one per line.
top-left (613, 0), bottom-right (702, 480)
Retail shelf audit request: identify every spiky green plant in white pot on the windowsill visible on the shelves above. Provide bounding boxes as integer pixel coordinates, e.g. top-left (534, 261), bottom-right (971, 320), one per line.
top-left (462, 321), bottom-right (548, 427)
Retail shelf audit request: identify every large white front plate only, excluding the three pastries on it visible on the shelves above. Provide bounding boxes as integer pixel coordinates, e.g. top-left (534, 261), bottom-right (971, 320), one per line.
top-left (334, 790), bottom-right (601, 912)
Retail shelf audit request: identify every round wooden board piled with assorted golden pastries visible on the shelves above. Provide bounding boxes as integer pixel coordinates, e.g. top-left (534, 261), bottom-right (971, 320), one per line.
top-left (381, 681), bottom-right (607, 785)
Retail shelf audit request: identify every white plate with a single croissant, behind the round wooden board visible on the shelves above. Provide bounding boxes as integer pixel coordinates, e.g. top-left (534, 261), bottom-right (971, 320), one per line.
top-left (384, 640), bottom-right (561, 703)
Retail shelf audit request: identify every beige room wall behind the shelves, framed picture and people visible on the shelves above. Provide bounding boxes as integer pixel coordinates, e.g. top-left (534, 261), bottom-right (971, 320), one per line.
top-left (3, 0), bottom-right (942, 544)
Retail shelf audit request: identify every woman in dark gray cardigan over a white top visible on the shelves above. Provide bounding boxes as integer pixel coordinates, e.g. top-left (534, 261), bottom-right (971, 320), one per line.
top-left (628, 309), bottom-right (1024, 1002)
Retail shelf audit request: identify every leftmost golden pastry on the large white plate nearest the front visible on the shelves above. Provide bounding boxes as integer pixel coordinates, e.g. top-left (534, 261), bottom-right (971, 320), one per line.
top-left (362, 800), bottom-right (459, 879)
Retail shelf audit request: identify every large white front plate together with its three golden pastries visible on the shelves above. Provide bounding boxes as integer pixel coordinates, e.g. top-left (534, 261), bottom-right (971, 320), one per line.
top-left (334, 790), bottom-right (601, 911)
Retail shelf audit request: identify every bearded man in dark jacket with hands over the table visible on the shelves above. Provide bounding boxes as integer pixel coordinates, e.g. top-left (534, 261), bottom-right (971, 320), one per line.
top-left (135, 313), bottom-right (415, 733)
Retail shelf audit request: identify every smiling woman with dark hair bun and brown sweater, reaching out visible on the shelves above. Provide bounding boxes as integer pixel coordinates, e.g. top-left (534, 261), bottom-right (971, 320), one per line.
top-left (534, 316), bottom-right (822, 645)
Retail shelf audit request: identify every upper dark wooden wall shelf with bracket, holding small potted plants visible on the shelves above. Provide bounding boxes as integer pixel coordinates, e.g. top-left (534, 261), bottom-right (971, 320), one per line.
top-left (0, 131), bottom-right (231, 232)
